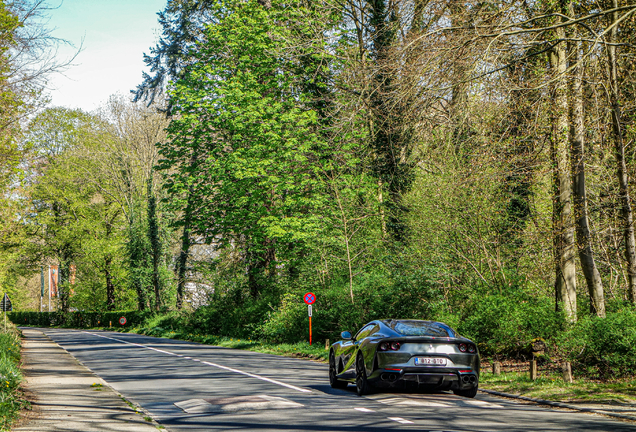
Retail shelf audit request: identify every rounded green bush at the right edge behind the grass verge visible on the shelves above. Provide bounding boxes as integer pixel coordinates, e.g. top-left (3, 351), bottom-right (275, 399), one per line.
top-left (557, 309), bottom-right (636, 379)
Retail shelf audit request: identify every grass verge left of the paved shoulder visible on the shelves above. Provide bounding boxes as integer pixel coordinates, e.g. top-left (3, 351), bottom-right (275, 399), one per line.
top-left (0, 323), bottom-right (29, 431)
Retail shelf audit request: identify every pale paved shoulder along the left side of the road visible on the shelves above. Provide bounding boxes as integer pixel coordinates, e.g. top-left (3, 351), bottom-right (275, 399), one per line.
top-left (13, 329), bottom-right (157, 432)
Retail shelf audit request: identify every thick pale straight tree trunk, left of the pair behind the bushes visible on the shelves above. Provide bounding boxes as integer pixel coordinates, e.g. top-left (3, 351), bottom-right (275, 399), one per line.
top-left (550, 32), bottom-right (576, 322)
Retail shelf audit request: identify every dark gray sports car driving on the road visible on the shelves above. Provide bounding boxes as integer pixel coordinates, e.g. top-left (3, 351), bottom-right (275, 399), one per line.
top-left (329, 319), bottom-right (479, 398)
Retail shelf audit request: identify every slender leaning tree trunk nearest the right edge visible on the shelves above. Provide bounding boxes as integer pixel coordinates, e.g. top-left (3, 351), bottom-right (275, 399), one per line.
top-left (607, 0), bottom-right (636, 305)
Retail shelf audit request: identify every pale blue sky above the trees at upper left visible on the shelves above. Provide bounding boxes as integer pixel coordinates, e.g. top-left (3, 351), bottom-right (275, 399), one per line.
top-left (48, 0), bottom-right (166, 111)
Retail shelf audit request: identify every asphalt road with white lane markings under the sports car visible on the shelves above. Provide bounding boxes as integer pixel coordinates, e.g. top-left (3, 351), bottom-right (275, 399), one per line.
top-left (38, 329), bottom-right (636, 432)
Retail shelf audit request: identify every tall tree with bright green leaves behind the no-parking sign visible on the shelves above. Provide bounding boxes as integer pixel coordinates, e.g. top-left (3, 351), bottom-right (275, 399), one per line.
top-left (160, 0), bottom-right (338, 296)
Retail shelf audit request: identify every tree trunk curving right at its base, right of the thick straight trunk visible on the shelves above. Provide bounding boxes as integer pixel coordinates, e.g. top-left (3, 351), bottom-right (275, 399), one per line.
top-left (569, 42), bottom-right (605, 317)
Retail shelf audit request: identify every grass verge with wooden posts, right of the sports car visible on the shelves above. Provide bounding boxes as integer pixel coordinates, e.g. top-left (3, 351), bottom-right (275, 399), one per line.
top-left (480, 372), bottom-right (636, 405)
